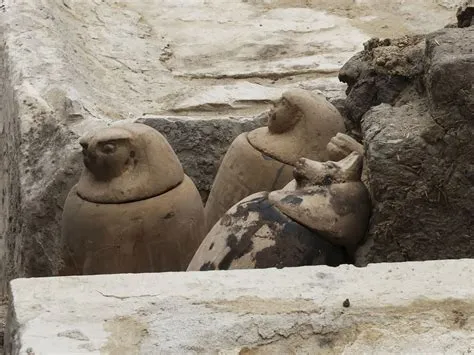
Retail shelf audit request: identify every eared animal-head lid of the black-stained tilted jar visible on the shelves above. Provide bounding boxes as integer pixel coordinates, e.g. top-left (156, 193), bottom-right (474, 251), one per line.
top-left (268, 152), bottom-right (371, 246)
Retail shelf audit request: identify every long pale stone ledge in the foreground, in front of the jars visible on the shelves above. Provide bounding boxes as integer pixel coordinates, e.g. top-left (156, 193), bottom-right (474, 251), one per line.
top-left (6, 259), bottom-right (474, 355)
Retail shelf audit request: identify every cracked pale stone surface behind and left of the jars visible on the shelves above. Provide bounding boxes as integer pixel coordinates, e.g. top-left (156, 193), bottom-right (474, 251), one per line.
top-left (0, 0), bottom-right (455, 286)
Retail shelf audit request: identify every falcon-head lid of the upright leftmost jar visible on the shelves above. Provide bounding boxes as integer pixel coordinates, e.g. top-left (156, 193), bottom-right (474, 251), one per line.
top-left (77, 123), bottom-right (184, 203)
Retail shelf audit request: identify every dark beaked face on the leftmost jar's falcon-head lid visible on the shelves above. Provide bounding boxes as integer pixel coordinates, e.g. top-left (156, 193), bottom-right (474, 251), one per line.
top-left (80, 138), bottom-right (135, 181)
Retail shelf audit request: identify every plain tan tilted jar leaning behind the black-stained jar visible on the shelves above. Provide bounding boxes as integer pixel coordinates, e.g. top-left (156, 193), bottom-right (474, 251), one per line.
top-left (205, 89), bottom-right (345, 230)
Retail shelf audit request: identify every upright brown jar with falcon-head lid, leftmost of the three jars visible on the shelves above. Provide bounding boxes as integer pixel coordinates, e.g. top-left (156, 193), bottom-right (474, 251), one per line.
top-left (62, 123), bottom-right (205, 275)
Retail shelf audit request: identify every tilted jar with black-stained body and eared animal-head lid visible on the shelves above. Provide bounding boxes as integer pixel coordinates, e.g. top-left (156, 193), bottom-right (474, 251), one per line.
top-left (188, 152), bottom-right (370, 271)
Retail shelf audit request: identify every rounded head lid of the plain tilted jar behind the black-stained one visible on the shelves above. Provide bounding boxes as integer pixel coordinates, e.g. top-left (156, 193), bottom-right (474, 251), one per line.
top-left (248, 89), bottom-right (345, 165)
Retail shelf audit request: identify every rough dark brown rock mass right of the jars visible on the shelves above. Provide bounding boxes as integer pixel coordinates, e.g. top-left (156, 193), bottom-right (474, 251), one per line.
top-left (343, 27), bottom-right (474, 265)
